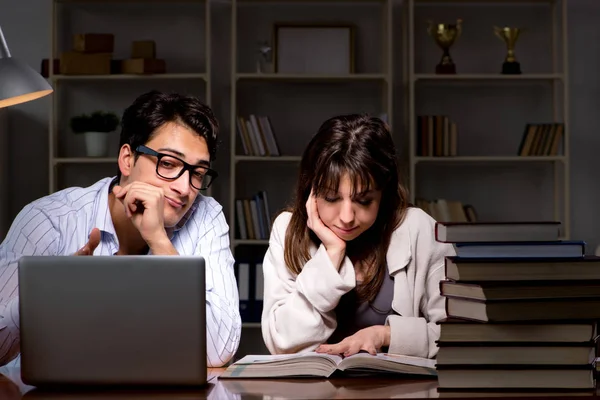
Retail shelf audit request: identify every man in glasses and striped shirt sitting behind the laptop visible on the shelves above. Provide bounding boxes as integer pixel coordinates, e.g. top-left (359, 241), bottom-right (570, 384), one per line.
top-left (0, 91), bottom-right (241, 366)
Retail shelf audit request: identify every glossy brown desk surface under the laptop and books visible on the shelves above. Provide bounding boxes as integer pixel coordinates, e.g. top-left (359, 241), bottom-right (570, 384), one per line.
top-left (0, 367), bottom-right (597, 400)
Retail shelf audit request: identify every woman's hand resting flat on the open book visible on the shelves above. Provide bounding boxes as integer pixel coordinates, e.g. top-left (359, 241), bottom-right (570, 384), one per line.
top-left (315, 325), bottom-right (390, 357)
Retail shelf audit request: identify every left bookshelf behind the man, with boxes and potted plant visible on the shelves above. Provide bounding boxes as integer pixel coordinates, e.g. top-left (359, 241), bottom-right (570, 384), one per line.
top-left (48, 0), bottom-right (211, 195)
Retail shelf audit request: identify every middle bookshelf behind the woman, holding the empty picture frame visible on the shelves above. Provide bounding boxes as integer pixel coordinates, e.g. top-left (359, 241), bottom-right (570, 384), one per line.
top-left (228, 0), bottom-right (394, 328)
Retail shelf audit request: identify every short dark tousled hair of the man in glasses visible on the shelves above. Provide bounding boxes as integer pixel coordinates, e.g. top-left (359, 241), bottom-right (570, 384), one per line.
top-left (117, 90), bottom-right (219, 179)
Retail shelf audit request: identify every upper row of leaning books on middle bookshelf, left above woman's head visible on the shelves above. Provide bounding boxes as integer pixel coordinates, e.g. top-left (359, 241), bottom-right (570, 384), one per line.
top-left (237, 114), bottom-right (281, 157)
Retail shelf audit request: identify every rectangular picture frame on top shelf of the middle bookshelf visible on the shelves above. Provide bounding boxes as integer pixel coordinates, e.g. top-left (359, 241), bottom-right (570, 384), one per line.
top-left (273, 23), bottom-right (355, 75)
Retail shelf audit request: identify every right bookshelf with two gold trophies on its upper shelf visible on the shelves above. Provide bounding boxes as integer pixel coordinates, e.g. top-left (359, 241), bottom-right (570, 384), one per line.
top-left (403, 0), bottom-right (570, 239)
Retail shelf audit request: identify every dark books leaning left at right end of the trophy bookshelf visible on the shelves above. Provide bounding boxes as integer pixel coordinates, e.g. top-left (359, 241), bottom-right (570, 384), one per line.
top-left (518, 123), bottom-right (565, 156)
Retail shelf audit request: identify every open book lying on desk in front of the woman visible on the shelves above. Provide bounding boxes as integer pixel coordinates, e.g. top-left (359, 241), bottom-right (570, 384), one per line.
top-left (219, 352), bottom-right (437, 378)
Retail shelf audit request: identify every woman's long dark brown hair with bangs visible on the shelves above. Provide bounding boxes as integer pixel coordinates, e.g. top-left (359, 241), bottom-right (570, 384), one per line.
top-left (284, 114), bottom-right (409, 301)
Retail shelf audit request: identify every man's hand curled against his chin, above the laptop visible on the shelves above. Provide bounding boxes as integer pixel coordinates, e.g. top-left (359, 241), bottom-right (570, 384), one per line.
top-left (113, 182), bottom-right (179, 255)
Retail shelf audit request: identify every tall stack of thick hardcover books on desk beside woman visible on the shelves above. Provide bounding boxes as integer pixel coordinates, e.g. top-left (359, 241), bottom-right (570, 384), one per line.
top-left (436, 222), bottom-right (600, 393)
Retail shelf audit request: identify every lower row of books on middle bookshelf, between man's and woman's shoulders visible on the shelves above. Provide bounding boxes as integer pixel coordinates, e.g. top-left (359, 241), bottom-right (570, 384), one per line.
top-left (235, 190), bottom-right (272, 240)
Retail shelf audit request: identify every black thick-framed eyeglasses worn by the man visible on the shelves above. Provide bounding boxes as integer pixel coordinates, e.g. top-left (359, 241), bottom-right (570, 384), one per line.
top-left (135, 146), bottom-right (219, 190)
